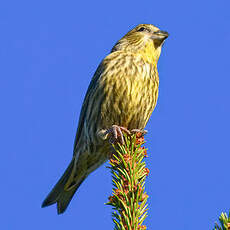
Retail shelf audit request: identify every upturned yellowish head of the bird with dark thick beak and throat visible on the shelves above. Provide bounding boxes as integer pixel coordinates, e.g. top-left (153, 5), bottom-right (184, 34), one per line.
top-left (112, 24), bottom-right (169, 62)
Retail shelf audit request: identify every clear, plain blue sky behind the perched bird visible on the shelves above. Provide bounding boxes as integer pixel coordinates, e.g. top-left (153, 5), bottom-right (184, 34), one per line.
top-left (0, 0), bottom-right (230, 230)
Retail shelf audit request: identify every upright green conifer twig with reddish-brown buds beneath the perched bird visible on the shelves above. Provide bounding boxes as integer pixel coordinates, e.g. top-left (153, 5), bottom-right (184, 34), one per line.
top-left (107, 134), bottom-right (148, 230)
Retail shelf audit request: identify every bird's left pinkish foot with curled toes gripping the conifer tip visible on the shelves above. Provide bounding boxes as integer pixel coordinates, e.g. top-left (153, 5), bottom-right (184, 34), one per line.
top-left (98, 125), bottom-right (131, 145)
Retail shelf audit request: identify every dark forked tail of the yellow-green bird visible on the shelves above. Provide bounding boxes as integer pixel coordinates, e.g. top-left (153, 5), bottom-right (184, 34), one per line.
top-left (42, 158), bottom-right (85, 214)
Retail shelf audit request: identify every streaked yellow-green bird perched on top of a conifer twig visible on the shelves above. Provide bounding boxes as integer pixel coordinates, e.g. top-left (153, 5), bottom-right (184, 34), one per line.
top-left (42, 24), bottom-right (168, 214)
